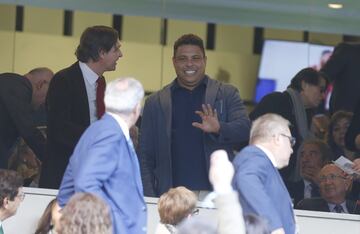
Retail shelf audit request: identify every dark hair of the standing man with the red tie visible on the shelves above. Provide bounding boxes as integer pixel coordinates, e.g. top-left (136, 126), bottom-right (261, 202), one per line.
top-left (75, 25), bottom-right (119, 63)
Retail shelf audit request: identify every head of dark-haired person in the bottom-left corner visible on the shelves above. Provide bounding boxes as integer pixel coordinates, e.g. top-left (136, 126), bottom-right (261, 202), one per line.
top-left (0, 169), bottom-right (25, 220)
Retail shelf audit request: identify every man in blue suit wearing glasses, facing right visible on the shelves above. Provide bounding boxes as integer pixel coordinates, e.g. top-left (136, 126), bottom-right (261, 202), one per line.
top-left (233, 114), bottom-right (296, 234)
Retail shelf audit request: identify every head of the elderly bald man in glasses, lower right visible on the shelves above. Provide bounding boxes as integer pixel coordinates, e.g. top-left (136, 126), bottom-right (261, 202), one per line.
top-left (319, 164), bottom-right (351, 204)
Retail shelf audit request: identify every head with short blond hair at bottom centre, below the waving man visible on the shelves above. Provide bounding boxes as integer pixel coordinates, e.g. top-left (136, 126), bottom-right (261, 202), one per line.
top-left (158, 186), bottom-right (197, 226)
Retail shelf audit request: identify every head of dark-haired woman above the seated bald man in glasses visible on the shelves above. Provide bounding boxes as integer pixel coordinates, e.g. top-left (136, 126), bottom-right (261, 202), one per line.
top-left (328, 111), bottom-right (353, 148)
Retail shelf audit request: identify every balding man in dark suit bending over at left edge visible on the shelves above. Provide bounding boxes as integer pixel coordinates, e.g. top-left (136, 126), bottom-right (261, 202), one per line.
top-left (0, 68), bottom-right (53, 168)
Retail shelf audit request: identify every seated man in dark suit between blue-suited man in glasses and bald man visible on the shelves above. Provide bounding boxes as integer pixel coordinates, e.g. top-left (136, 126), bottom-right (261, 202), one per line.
top-left (286, 139), bottom-right (333, 205)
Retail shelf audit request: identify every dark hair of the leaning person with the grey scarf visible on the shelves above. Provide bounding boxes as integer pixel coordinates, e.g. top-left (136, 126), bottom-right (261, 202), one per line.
top-left (289, 67), bottom-right (327, 92)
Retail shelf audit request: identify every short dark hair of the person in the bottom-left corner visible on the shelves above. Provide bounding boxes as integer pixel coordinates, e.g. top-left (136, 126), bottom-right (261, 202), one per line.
top-left (0, 169), bottom-right (23, 207)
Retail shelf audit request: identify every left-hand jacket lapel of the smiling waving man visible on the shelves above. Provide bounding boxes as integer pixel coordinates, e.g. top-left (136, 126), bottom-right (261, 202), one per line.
top-left (159, 82), bottom-right (174, 139)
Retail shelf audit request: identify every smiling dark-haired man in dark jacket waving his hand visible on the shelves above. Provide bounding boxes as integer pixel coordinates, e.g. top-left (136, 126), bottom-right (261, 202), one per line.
top-left (139, 34), bottom-right (250, 197)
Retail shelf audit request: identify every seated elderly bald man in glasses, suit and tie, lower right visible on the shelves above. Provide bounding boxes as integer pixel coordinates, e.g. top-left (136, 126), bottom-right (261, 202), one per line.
top-left (296, 164), bottom-right (360, 214)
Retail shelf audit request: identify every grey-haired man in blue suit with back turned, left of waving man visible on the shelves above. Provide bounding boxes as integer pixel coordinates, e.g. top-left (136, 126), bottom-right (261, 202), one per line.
top-left (57, 78), bottom-right (147, 234)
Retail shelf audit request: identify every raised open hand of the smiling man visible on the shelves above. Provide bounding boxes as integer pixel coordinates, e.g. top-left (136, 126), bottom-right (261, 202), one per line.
top-left (192, 104), bottom-right (220, 133)
